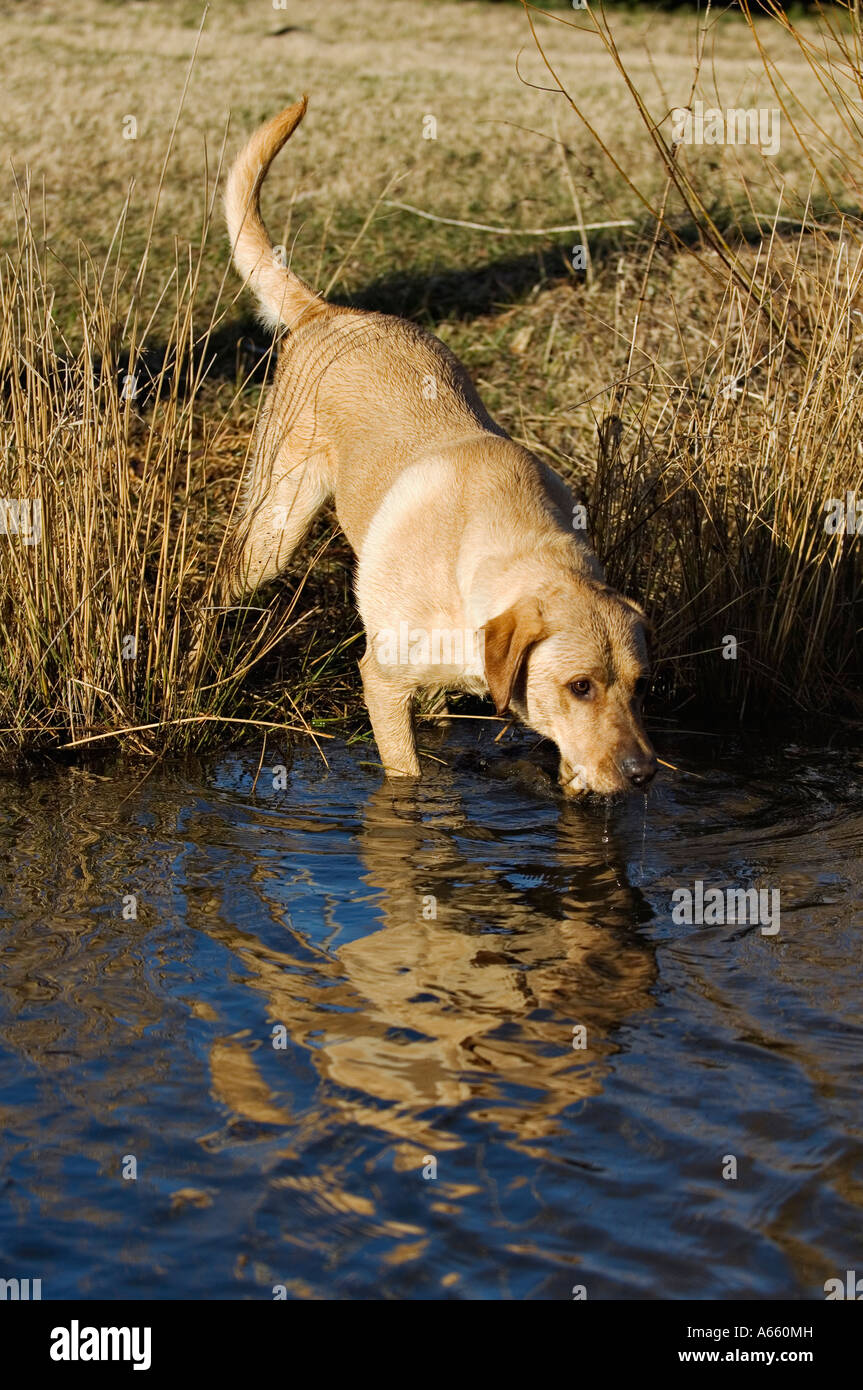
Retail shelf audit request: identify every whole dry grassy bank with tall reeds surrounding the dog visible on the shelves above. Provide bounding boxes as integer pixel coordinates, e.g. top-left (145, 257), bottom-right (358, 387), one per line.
top-left (0, 0), bottom-right (863, 752)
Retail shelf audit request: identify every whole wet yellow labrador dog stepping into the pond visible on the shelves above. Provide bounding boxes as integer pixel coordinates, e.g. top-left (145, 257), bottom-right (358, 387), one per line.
top-left (222, 97), bottom-right (656, 796)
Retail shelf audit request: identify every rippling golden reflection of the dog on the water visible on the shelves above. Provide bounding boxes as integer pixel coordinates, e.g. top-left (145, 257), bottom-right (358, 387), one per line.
top-left (203, 770), bottom-right (656, 1166)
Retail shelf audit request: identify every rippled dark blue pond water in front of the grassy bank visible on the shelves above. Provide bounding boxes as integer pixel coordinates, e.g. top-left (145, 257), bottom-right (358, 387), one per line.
top-left (0, 721), bottom-right (863, 1300)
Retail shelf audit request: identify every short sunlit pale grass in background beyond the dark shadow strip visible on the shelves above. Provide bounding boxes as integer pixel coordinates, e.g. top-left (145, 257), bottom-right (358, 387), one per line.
top-left (0, 0), bottom-right (842, 317)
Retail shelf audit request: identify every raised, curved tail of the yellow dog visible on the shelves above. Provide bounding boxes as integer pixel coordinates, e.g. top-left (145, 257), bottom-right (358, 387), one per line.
top-left (225, 96), bottom-right (329, 328)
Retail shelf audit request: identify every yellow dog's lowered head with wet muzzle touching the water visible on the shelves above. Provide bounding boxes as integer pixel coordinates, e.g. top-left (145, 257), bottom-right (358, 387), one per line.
top-left (484, 578), bottom-right (656, 796)
